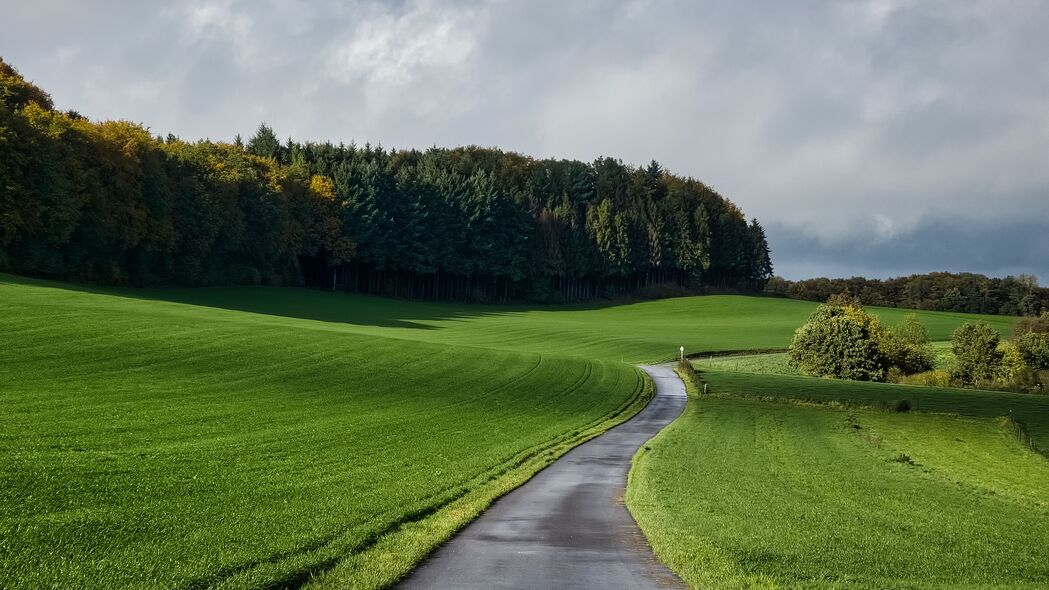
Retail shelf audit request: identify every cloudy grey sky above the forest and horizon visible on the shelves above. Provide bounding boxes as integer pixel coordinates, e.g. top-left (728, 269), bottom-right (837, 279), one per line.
top-left (0, 0), bottom-right (1049, 279)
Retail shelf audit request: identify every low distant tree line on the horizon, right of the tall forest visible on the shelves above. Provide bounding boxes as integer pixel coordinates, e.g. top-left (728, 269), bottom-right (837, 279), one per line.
top-left (765, 273), bottom-right (1049, 316)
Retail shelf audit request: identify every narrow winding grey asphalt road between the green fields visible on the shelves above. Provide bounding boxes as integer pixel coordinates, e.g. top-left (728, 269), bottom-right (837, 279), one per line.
top-left (398, 366), bottom-right (685, 590)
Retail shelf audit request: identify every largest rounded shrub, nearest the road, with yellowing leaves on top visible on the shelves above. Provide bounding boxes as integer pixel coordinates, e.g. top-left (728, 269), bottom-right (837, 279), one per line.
top-left (789, 303), bottom-right (890, 381)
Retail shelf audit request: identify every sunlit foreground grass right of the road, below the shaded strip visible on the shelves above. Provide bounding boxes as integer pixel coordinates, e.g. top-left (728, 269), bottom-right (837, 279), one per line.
top-left (627, 392), bottom-right (1049, 589)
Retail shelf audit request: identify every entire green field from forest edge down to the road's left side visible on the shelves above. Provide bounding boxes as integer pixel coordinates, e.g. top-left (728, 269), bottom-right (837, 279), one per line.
top-left (0, 275), bottom-right (1032, 589)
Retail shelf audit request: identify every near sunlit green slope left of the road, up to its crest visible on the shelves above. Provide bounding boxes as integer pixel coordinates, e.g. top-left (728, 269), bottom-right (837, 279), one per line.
top-left (0, 278), bottom-right (643, 590)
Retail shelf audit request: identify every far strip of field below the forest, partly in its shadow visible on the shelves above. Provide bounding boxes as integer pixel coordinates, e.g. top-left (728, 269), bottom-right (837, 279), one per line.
top-left (16, 275), bottom-right (1015, 363)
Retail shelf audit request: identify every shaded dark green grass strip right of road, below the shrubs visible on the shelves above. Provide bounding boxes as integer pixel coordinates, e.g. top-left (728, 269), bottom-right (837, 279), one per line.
top-left (699, 364), bottom-right (1049, 451)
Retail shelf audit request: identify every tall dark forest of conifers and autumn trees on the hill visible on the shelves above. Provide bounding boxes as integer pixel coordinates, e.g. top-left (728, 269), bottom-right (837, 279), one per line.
top-left (0, 61), bottom-right (772, 301)
